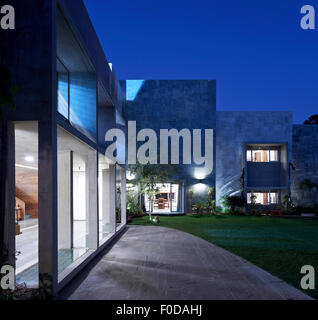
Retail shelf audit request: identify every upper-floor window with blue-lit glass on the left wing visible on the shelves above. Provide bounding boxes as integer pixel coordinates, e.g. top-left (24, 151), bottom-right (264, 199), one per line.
top-left (56, 10), bottom-right (97, 142)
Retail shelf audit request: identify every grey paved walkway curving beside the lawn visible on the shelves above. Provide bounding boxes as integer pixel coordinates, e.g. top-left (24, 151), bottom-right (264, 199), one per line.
top-left (65, 226), bottom-right (310, 300)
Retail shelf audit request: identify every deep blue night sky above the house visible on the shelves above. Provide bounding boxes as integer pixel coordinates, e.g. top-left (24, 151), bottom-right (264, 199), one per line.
top-left (84, 0), bottom-right (318, 123)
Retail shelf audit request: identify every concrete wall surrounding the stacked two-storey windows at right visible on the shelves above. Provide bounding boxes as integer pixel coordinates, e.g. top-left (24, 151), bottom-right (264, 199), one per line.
top-left (216, 111), bottom-right (292, 204)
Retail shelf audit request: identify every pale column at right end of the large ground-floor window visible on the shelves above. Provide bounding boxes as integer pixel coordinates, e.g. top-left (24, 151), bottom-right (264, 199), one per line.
top-left (86, 151), bottom-right (98, 249)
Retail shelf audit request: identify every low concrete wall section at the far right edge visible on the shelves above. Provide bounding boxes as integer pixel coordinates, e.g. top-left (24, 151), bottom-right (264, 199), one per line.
top-left (292, 125), bottom-right (318, 206)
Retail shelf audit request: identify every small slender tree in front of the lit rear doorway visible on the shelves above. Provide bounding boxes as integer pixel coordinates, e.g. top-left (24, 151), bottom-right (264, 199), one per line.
top-left (128, 164), bottom-right (176, 221)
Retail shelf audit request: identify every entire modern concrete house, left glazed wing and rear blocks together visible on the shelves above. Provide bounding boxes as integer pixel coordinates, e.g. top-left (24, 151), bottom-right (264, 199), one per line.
top-left (1, 0), bottom-right (318, 294)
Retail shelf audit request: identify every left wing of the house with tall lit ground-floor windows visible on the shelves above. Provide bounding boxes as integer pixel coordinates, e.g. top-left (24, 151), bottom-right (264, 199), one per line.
top-left (1, 0), bottom-right (126, 294)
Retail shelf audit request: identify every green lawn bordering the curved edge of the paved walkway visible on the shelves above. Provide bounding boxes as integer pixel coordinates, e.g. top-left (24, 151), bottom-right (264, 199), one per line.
top-left (131, 215), bottom-right (318, 299)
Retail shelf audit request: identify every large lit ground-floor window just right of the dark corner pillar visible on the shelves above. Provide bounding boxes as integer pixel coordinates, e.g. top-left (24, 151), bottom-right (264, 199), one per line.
top-left (58, 128), bottom-right (97, 273)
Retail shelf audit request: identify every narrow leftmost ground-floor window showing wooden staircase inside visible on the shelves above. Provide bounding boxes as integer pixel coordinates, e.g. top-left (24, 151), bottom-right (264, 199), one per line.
top-left (12, 121), bottom-right (39, 286)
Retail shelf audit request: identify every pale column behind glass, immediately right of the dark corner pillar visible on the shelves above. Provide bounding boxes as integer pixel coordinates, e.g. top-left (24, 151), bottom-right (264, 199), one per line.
top-left (57, 151), bottom-right (72, 249)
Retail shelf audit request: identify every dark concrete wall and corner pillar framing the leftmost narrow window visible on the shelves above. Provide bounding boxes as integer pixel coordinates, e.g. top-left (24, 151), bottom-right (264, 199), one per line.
top-left (1, 0), bottom-right (57, 293)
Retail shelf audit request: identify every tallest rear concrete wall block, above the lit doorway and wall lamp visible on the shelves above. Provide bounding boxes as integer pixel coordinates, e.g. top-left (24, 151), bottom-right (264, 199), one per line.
top-left (122, 80), bottom-right (216, 210)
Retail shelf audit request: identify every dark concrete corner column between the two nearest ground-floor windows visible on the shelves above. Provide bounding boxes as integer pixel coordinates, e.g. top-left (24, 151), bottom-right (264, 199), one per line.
top-left (39, 120), bottom-right (58, 295)
